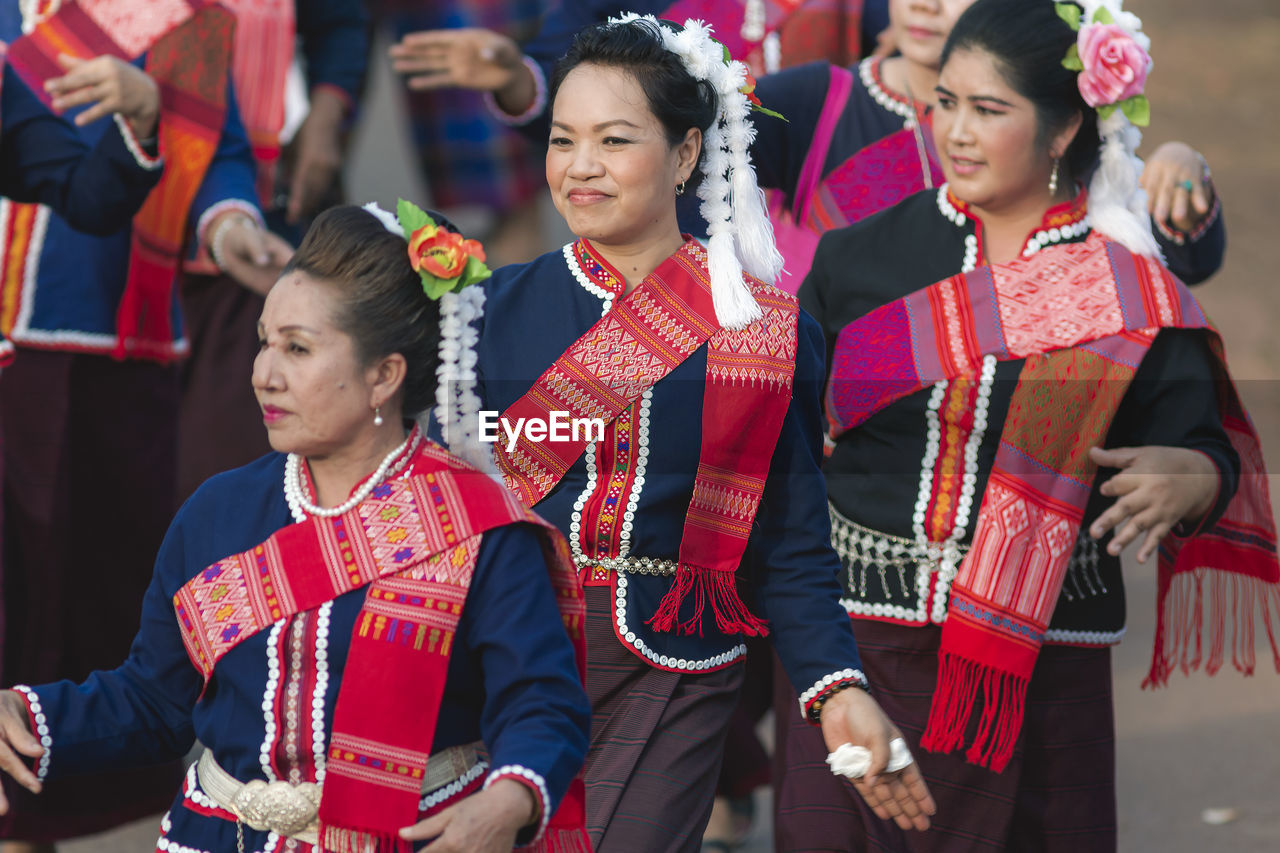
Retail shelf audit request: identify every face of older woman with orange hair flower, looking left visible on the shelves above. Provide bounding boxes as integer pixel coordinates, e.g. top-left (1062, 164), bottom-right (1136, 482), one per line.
top-left (253, 270), bottom-right (387, 457)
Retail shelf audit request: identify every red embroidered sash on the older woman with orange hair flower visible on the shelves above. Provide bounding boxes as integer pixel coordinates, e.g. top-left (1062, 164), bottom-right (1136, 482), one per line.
top-left (174, 447), bottom-right (585, 852)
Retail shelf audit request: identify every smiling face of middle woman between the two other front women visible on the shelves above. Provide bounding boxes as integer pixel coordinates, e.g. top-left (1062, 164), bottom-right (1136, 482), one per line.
top-left (547, 63), bottom-right (701, 246)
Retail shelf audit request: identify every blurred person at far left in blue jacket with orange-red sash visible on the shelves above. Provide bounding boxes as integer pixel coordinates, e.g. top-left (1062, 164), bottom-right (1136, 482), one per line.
top-left (0, 0), bottom-right (288, 841)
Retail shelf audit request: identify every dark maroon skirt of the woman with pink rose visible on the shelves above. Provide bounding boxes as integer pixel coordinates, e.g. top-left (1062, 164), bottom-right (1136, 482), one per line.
top-left (774, 620), bottom-right (1116, 853)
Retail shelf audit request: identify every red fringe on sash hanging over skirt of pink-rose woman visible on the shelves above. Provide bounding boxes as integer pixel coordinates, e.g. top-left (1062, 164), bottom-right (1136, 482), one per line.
top-left (920, 653), bottom-right (1028, 774)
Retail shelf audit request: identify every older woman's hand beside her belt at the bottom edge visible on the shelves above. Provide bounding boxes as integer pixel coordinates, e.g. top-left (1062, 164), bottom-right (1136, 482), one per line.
top-left (401, 779), bottom-right (538, 853)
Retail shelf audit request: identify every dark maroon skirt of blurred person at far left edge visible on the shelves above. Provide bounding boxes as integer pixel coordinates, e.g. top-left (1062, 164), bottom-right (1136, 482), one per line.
top-left (0, 350), bottom-right (182, 840)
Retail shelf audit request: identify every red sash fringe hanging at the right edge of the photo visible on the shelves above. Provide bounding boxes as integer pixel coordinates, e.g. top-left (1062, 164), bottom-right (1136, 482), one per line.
top-left (1142, 570), bottom-right (1280, 688)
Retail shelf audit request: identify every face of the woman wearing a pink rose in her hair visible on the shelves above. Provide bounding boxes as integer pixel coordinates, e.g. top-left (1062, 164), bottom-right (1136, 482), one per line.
top-left (933, 49), bottom-right (1080, 211)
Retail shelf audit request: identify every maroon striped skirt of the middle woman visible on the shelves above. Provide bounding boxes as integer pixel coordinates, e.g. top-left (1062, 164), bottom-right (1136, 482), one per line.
top-left (586, 587), bottom-right (742, 853)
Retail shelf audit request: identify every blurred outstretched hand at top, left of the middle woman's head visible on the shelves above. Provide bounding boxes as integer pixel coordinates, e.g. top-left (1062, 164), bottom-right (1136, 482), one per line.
top-left (390, 27), bottom-right (536, 115)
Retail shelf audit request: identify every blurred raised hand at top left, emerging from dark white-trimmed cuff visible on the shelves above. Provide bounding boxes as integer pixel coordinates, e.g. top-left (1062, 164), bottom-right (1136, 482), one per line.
top-left (45, 54), bottom-right (160, 140)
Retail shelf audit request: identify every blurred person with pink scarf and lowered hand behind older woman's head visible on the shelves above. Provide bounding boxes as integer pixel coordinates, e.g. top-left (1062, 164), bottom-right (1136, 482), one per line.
top-left (178, 0), bottom-right (369, 501)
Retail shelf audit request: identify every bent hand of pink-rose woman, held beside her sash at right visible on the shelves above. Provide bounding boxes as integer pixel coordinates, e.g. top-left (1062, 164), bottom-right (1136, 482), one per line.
top-left (1089, 446), bottom-right (1219, 562)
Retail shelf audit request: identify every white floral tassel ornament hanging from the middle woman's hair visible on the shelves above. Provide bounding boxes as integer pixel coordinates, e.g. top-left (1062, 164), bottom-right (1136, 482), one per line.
top-left (609, 13), bottom-right (782, 329)
